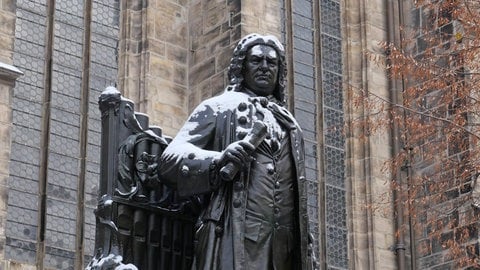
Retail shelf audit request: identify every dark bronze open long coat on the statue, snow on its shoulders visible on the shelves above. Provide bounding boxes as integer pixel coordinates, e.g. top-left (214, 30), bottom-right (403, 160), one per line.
top-left (160, 91), bottom-right (314, 270)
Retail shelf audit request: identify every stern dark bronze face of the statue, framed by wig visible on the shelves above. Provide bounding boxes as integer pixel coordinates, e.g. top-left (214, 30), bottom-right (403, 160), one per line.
top-left (244, 45), bottom-right (279, 96)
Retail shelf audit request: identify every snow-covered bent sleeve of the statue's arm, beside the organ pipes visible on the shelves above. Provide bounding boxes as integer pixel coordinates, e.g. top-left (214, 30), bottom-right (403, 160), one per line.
top-left (159, 102), bottom-right (221, 196)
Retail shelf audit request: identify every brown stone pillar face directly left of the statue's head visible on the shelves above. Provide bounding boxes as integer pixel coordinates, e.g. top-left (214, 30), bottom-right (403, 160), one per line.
top-left (188, 0), bottom-right (242, 115)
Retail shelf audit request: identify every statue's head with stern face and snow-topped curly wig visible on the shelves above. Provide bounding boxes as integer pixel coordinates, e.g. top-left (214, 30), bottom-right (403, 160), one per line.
top-left (227, 34), bottom-right (287, 105)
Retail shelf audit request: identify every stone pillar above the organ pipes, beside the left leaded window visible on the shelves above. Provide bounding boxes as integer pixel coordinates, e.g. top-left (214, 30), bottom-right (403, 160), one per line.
top-left (118, 0), bottom-right (190, 137)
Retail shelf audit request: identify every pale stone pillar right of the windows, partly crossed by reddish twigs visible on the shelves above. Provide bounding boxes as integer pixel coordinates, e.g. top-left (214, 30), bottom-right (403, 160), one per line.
top-left (344, 0), bottom-right (396, 269)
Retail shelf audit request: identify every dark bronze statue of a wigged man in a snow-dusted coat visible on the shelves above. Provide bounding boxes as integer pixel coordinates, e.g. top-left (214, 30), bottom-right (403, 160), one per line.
top-left (160, 34), bottom-right (312, 270)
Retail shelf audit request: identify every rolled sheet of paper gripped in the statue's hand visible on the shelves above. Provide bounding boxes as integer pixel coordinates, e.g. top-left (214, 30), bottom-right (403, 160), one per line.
top-left (220, 121), bottom-right (268, 181)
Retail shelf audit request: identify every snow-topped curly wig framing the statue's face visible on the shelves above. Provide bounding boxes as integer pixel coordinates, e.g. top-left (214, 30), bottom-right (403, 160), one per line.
top-left (227, 33), bottom-right (287, 105)
